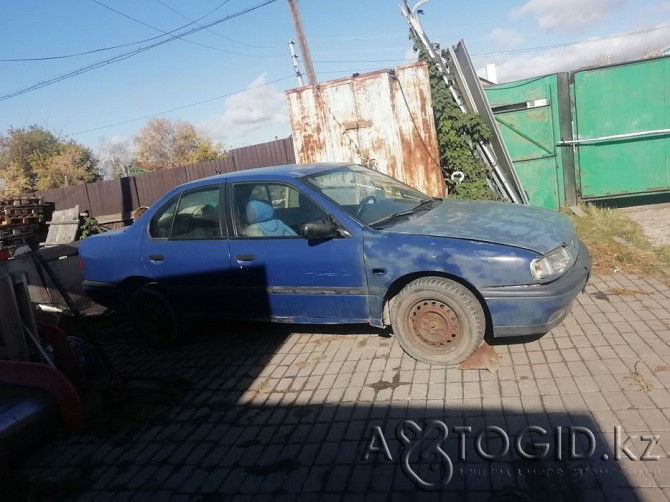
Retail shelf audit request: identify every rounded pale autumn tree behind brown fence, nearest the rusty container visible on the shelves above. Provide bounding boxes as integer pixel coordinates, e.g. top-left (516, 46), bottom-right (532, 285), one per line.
top-left (133, 118), bottom-right (226, 171)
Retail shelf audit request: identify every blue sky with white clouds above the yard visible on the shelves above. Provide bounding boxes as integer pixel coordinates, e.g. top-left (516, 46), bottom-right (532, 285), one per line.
top-left (0, 0), bottom-right (670, 157)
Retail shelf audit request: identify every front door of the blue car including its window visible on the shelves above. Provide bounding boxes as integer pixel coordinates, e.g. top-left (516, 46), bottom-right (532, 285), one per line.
top-left (229, 181), bottom-right (370, 323)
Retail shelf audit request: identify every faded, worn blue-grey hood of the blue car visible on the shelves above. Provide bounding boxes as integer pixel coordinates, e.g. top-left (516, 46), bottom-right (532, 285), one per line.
top-left (389, 200), bottom-right (576, 254)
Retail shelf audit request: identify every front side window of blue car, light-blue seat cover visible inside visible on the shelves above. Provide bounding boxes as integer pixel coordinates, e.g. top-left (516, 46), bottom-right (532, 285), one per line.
top-left (232, 182), bottom-right (328, 238)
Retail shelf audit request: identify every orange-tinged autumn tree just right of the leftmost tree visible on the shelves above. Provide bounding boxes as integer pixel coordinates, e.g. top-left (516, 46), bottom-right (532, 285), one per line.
top-left (31, 141), bottom-right (100, 190)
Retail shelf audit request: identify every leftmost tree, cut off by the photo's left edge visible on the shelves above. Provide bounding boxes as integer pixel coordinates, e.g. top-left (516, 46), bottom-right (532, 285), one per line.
top-left (0, 125), bottom-right (59, 195)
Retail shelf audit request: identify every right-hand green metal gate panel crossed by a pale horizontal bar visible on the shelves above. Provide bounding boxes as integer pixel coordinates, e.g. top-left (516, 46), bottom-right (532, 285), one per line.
top-left (566, 58), bottom-right (670, 199)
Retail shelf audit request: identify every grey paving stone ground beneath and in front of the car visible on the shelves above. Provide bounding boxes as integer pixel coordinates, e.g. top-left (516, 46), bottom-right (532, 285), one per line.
top-left (0, 275), bottom-right (670, 502)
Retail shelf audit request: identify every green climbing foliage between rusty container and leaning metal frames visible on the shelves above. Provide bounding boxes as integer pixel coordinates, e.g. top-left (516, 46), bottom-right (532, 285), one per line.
top-left (410, 34), bottom-right (503, 200)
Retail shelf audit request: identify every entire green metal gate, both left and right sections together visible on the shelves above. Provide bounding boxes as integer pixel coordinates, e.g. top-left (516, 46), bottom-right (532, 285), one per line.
top-left (486, 56), bottom-right (670, 208)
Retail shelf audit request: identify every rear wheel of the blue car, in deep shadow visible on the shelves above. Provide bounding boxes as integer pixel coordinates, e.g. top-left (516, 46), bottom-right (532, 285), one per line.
top-left (129, 286), bottom-right (179, 349)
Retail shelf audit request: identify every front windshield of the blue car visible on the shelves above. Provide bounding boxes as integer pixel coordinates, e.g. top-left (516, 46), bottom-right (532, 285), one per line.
top-left (302, 165), bottom-right (438, 227)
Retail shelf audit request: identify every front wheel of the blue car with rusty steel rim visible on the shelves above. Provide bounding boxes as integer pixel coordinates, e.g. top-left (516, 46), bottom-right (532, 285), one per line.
top-left (390, 277), bottom-right (486, 366)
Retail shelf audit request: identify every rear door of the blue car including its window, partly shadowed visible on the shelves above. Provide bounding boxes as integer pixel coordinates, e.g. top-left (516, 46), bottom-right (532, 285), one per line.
top-left (142, 184), bottom-right (231, 314)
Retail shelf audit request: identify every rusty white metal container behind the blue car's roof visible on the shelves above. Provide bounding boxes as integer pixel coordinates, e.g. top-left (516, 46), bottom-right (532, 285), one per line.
top-left (286, 62), bottom-right (446, 197)
